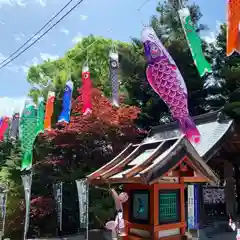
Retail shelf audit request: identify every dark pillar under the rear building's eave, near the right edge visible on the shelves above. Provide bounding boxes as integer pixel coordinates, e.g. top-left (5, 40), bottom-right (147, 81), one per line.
top-left (224, 161), bottom-right (236, 219)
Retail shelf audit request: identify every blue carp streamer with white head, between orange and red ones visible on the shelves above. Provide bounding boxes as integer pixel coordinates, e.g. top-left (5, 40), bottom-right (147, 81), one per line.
top-left (58, 81), bottom-right (73, 123)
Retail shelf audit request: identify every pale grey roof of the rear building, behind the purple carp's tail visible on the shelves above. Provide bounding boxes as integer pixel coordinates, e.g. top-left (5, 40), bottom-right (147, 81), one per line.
top-left (143, 111), bottom-right (233, 161)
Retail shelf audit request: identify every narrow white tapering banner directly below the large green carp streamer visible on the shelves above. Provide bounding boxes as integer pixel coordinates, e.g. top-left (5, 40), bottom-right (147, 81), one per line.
top-left (21, 173), bottom-right (32, 240)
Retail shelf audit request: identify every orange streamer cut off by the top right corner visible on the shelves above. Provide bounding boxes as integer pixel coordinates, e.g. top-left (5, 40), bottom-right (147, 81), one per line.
top-left (227, 0), bottom-right (240, 56)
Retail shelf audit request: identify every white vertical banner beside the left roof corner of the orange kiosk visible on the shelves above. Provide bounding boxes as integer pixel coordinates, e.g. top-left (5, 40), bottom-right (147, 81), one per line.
top-left (76, 179), bottom-right (89, 228)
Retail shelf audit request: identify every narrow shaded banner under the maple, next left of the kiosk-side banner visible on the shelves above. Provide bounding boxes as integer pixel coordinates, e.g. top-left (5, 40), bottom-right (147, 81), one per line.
top-left (53, 182), bottom-right (63, 231)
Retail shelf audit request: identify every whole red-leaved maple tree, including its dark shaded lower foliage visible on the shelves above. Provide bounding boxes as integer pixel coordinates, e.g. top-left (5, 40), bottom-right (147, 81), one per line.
top-left (16, 88), bottom-right (145, 236)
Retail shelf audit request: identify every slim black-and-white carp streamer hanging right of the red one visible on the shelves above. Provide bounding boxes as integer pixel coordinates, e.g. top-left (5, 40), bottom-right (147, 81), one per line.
top-left (109, 49), bottom-right (119, 107)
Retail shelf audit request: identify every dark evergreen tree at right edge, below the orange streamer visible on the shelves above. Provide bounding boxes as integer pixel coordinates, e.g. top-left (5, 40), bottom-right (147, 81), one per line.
top-left (207, 24), bottom-right (240, 120)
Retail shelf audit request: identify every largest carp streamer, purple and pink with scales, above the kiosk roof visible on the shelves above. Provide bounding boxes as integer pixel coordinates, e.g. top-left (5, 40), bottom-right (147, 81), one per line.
top-left (142, 27), bottom-right (200, 143)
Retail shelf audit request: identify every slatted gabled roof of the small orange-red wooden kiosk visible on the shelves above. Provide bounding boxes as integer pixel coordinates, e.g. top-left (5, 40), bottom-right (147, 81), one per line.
top-left (87, 136), bottom-right (219, 184)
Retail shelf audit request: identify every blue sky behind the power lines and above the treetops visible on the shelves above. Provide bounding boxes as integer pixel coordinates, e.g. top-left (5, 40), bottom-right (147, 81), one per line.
top-left (0, 0), bottom-right (226, 114)
